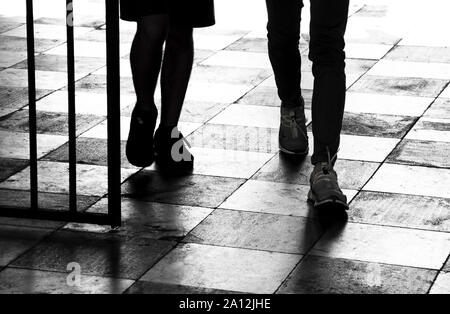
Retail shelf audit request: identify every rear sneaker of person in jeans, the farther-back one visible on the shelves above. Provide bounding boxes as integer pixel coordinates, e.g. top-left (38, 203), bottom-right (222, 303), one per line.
top-left (279, 106), bottom-right (309, 156)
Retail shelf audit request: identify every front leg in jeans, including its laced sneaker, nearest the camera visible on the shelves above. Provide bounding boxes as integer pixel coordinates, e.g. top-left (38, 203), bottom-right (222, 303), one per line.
top-left (309, 0), bottom-right (349, 209)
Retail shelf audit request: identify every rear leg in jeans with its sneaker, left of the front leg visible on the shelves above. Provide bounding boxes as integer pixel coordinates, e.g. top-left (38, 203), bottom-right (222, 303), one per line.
top-left (266, 0), bottom-right (308, 156)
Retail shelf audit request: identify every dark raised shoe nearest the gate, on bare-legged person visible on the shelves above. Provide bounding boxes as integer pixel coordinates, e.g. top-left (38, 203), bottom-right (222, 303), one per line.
top-left (126, 107), bottom-right (158, 168)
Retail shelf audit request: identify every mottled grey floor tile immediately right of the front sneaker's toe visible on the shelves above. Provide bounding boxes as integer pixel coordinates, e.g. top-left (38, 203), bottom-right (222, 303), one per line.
top-left (349, 192), bottom-right (450, 232)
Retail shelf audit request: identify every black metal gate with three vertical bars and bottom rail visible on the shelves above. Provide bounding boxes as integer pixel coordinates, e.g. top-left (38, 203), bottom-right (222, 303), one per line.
top-left (0, 0), bottom-right (121, 227)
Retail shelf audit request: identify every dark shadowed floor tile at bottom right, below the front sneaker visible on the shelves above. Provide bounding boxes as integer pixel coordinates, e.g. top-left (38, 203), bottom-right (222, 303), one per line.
top-left (278, 256), bottom-right (436, 294)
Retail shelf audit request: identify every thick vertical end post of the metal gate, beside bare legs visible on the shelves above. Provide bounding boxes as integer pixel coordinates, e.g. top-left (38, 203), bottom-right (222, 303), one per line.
top-left (105, 0), bottom-right (121, 227)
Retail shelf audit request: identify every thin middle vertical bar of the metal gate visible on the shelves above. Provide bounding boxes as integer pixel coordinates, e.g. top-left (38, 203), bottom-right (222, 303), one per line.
top-left (66, 0), bottom-right (77, 213)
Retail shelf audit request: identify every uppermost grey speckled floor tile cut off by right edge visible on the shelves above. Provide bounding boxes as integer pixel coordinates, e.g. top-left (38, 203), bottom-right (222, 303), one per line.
top-left (385, 45), bottom-right (450, 63)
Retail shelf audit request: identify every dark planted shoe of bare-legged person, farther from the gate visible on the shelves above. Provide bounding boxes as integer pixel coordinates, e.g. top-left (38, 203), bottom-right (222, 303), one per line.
top-left (155, 127), bottom-right (194, 172)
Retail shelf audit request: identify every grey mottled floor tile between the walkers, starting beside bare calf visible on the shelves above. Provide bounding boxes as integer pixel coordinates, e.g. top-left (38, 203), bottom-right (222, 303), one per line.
top-left (191, 65), bottom-right (272, 86)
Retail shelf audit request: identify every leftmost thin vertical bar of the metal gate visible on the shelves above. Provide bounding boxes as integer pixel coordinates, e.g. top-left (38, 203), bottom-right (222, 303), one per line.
top-left (27, 0), bottom-right (39, 210)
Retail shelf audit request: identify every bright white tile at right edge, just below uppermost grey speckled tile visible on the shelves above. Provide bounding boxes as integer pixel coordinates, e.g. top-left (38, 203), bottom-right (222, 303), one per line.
top-left (367, 60), bottom-right (450, 80)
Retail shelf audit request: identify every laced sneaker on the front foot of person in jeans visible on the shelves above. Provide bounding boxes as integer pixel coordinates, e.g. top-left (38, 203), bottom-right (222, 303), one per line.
top-left (308, 162), bottom-right (349, 210)
